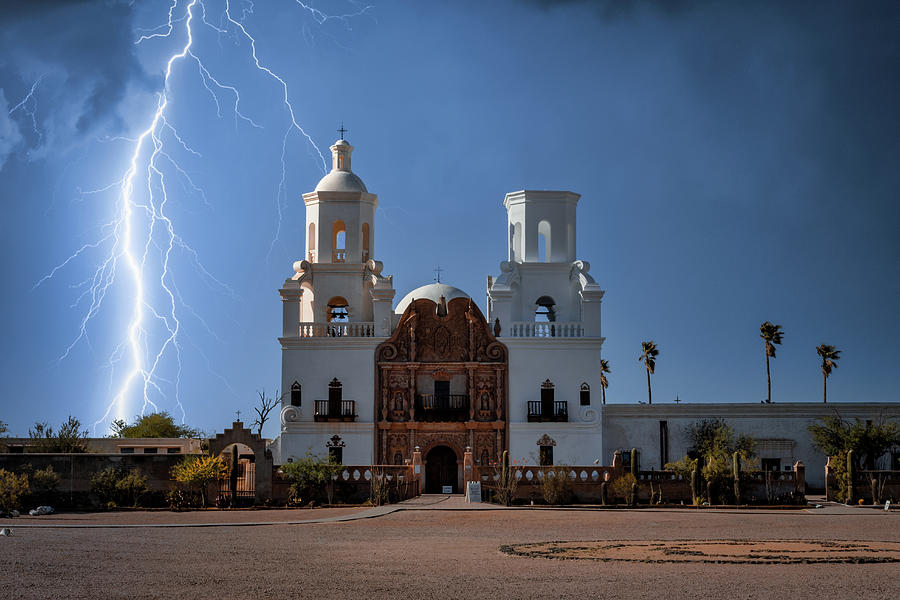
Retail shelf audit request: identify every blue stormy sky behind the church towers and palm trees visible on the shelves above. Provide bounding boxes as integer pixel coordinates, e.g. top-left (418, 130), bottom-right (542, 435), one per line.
top-left (0, 0), bottom-right (900, 436)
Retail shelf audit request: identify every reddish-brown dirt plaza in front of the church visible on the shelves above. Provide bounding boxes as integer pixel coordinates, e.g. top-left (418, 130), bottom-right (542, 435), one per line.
top-left (0, 496), bottom-right (900, 599)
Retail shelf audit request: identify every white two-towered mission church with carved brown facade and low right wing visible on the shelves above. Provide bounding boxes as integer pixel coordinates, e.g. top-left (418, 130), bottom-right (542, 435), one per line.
top-left (269, 139), bottom-right (900, 491)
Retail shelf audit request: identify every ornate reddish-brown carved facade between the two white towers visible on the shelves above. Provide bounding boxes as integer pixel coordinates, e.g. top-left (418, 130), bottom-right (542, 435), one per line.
top-left (375, 297), bottom-right (508, 464)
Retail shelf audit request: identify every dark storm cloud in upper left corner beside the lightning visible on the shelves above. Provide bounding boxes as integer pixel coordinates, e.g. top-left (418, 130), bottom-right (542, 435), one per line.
top-left (0, 0), bottom-right (148, 156)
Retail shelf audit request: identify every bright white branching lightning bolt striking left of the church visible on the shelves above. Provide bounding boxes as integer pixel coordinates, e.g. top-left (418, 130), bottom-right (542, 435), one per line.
top-left (30, 0), bottom-right (372, 430)
